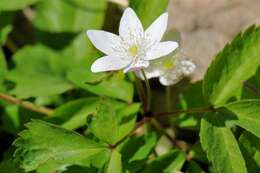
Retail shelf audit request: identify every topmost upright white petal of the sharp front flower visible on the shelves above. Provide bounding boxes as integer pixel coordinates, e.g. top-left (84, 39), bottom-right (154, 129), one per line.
top-left (119, 8), bottom-right (144, 41)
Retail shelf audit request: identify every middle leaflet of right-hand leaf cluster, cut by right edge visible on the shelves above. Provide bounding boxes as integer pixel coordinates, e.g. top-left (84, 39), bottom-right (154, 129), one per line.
top-left (221, 100), bottom-right (260, 138)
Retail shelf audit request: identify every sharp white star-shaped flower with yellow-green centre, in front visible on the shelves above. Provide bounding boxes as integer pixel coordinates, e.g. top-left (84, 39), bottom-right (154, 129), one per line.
top-left (87, 8), bottom-right (178, 72)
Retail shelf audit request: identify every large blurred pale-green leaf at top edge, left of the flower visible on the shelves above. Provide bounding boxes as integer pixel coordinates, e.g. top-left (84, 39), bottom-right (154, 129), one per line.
top-left (33, 0), bottom-right (106, 32)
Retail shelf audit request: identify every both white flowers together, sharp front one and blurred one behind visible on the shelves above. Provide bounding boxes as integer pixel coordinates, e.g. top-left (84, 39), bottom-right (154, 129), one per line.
top-left (87, 8), bottom-right (195, 85)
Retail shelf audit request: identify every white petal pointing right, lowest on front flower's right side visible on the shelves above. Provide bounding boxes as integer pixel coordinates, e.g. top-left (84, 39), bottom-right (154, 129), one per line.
top-left (146, 41), bottom-right (179, 60)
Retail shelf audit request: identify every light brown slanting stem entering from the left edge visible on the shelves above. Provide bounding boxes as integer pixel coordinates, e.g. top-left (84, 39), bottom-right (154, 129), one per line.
top-left (0, 93), bottom-right (53, 115)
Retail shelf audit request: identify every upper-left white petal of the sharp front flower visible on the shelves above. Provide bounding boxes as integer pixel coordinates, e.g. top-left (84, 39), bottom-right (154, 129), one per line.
top-left (87, 30), bottom-right (120, 55)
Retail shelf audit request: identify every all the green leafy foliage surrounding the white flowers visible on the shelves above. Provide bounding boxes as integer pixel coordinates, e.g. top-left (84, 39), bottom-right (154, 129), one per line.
top-left (0, 0), bottom-right (260, 173)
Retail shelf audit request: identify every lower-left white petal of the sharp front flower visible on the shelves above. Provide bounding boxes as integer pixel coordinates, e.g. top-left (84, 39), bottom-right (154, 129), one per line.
top-left (91, 56), bottom-right (131, 72)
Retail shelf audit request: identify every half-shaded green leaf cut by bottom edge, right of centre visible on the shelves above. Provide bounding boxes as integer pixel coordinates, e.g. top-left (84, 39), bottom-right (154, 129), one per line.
top-left (142, 150), bottom-right (186, 173)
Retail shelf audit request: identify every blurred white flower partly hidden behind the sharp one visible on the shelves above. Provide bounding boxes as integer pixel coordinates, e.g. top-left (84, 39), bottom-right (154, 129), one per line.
top-left (136, 52), bottom-right (196, 86)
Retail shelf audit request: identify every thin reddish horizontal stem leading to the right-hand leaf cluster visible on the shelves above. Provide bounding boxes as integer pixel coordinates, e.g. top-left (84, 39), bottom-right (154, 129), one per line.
top-left (154, 107), bottom-right (215, 117)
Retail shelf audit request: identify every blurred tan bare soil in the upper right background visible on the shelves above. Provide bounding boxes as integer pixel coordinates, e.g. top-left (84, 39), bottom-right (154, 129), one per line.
top-left (169, 0), bottom-right (260, 80)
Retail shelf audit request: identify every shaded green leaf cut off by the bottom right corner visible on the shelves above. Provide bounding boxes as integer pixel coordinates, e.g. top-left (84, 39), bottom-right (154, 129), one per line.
top-left (239, 132), bottom-right (260, 173)
